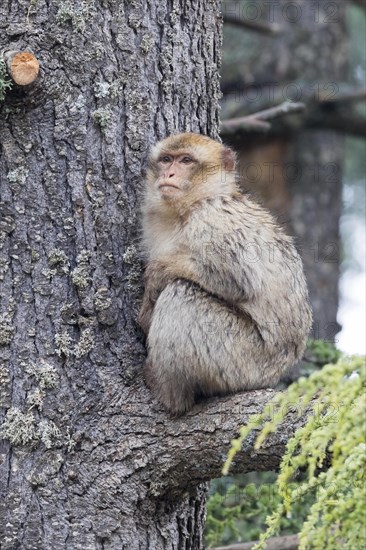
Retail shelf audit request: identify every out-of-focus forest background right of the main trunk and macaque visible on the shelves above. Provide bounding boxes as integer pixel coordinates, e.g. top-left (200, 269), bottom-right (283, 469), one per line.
top-left (206, 0), bottom-right (366, 550)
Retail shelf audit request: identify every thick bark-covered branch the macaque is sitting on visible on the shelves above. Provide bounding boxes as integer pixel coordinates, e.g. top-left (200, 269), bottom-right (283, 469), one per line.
top-left (144, 390), bottom-right (306, 497)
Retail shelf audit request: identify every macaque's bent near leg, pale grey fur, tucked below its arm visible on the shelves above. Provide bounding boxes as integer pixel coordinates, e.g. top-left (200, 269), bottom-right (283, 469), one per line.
top-left (145, 280), bottom-right (264, 414)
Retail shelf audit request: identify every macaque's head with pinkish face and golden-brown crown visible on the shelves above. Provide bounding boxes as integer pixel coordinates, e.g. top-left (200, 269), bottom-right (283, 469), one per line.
top-left (147, 133), bottom-right (237, 205)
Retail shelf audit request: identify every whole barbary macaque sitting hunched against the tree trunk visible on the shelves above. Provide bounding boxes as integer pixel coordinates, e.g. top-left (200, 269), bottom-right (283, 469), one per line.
top-left (139, 133), bottom-right (312, 415)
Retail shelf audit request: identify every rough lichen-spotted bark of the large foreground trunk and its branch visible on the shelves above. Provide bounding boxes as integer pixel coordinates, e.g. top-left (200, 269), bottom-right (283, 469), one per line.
top-left (0, 0), bottom-right (306, 550)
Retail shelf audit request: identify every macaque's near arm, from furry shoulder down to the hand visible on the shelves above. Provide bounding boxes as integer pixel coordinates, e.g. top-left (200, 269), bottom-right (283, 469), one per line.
top-left (140, 201), bottom-right (280, 332)
